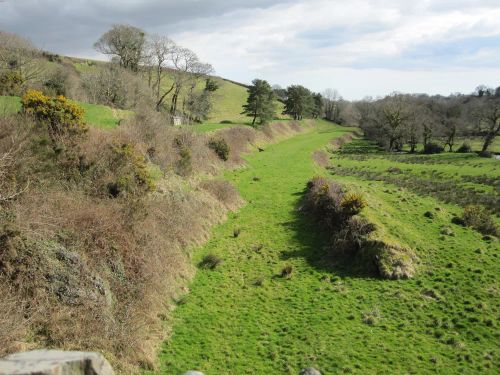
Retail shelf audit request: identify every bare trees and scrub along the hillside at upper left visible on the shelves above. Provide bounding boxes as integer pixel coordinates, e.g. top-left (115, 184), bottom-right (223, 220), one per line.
top-left (0, 25), bottom-right (218, 121)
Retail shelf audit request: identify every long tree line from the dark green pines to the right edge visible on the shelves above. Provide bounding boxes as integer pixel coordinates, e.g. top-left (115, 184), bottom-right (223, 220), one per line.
top-left (243, 79), bottom-right (500, 155)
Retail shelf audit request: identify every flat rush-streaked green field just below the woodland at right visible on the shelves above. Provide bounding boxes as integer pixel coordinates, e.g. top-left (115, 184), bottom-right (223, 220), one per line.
top-left (333, 140), bottom-right (500, 212)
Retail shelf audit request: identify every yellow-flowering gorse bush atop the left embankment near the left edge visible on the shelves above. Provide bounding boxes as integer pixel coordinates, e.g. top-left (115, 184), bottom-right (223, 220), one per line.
top-left (21, 90), bottom-right (88, 143)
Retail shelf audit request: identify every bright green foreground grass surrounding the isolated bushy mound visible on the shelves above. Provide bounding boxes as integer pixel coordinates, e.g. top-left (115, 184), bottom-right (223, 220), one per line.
top-left (154, 123), bottom-right (500, 375)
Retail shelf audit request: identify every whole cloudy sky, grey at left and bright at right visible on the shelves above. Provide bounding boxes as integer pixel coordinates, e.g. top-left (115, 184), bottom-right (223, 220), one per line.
top-left (0, 0), bottom-right (500, 99)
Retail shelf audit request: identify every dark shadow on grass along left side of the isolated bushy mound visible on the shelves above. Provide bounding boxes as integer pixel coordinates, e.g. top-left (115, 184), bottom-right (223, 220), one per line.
top-left (281, 190), bottom-right (380, 279)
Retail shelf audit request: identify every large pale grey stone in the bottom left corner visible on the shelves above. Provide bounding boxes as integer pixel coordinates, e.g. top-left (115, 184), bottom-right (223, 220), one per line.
top-left (0, 350), bottom-right (114, 375)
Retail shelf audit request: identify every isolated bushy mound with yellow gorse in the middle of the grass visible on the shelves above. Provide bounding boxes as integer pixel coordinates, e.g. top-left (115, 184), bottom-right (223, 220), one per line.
top-left (303, 177), bottom-right (416, 279)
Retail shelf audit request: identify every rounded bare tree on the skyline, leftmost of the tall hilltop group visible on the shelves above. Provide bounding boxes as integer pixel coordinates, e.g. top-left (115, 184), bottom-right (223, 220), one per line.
top-left (94, 25), bottom-right (146, 72)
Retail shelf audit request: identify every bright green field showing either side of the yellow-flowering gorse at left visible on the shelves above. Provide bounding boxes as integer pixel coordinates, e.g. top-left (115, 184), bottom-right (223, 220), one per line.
top-left (0, 96), bottom-right (133, 129)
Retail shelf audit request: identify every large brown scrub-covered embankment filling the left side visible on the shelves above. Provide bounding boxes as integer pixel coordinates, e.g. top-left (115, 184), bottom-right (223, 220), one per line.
top-left (0, 93), bottom-right (304, 373)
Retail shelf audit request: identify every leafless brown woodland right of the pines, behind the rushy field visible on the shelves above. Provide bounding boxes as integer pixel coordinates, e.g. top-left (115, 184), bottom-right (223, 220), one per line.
top-left (354, 86), bottom-right (500, 156)
